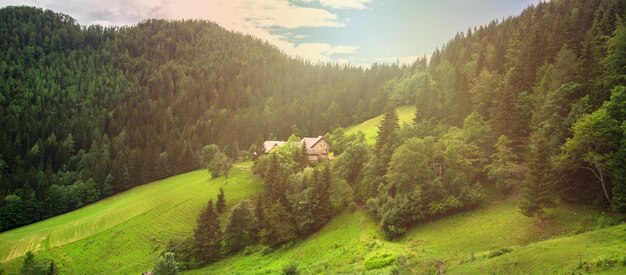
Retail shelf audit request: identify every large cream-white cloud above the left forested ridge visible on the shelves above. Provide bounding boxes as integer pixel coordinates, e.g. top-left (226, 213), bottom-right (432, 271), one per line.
top-left (0, 0), bottom-right (360, 62)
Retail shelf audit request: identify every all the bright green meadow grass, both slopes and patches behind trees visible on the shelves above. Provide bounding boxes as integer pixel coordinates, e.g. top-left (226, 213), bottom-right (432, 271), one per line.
top-left (0, 106), bottom-right (626, 274)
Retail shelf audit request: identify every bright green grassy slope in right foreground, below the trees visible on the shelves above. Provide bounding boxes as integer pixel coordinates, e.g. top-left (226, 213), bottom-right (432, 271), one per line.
top-left (189, 199), bottom-right (626, 274)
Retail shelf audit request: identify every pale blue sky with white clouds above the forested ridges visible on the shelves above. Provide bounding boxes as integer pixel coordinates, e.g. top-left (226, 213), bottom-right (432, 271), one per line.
top-left (0, 0), bottom-right (541, 66)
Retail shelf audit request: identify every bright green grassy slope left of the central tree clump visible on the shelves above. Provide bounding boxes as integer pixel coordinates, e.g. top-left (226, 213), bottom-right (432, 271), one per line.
top-left (0, 163), bottom-right (262, 274)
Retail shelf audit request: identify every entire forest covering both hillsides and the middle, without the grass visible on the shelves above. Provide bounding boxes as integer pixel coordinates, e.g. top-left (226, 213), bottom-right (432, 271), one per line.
top-left (0, 0), bottom-right (626, 265)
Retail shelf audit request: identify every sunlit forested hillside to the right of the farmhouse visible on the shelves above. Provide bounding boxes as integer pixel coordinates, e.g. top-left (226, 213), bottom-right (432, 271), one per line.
top-left (331, 0), bottom-right (626, 238)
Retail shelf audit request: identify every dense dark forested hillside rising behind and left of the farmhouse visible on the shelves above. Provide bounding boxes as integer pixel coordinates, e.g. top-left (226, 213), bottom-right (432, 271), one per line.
top-left (0, 7), bottom-right (403, 230)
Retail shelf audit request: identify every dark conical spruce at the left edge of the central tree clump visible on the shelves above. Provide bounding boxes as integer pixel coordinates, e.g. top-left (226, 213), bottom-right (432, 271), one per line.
top-left (194, 200), bottom-right (222, 264)
